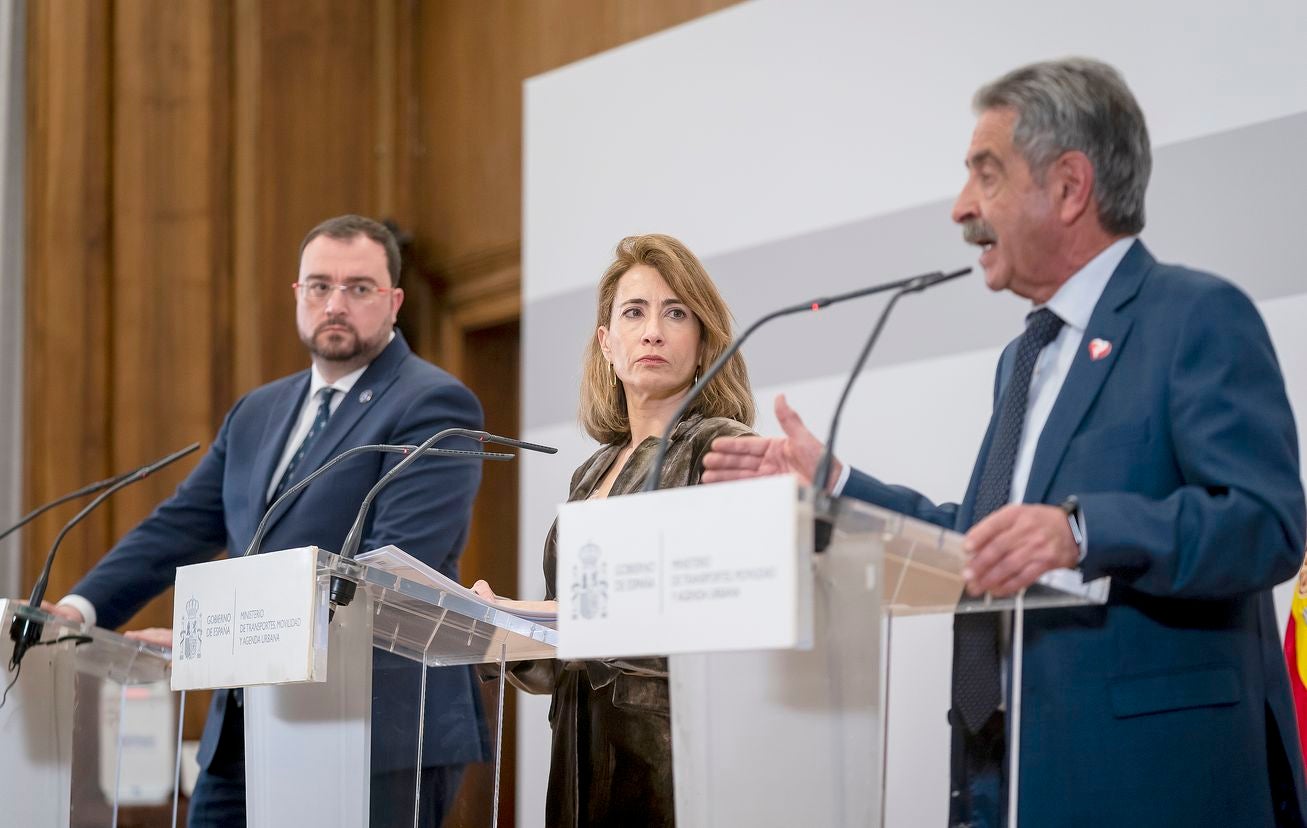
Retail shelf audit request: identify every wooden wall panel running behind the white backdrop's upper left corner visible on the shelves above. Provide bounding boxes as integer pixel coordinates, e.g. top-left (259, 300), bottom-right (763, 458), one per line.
top-left (414, 0), bottom-right (736, 281)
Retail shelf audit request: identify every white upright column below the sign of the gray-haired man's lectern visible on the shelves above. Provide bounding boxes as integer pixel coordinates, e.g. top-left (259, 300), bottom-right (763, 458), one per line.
top-left (669, 527), bottom-right (884, 827)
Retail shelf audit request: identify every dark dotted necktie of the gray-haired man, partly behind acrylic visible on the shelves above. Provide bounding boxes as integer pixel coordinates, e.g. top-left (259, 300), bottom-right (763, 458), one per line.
top-left (953, 308), bottom-right (1063, 733)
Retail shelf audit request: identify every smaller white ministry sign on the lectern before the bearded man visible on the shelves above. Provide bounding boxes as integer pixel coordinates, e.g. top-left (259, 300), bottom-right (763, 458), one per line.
top-left (173, 546), bottom-right (325, 690)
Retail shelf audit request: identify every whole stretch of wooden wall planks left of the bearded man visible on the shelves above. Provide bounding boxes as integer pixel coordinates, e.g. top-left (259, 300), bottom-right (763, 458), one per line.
top-left (25, 0), bottom-right (392, 613)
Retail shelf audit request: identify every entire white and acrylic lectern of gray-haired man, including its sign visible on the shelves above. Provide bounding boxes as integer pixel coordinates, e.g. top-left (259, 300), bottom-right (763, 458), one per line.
top-left (559, 478), bottom-right (1108, 828)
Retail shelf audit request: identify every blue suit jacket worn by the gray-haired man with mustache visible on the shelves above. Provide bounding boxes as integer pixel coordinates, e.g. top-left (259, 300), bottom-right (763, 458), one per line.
top-left (844, 243), bottom-right (1307, 827)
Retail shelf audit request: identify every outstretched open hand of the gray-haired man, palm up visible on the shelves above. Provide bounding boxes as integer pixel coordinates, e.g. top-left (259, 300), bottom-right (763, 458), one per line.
top-left (703, 394), bottom-right (843, 490)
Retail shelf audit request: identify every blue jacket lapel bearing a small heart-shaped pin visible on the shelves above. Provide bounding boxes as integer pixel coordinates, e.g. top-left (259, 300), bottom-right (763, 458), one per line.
top-left (1025, 242), bottom-right (1154, 503)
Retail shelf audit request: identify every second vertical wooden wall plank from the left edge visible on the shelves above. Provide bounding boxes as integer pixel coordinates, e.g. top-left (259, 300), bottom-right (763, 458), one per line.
top-left (106, 0), bottom-right (231, 608)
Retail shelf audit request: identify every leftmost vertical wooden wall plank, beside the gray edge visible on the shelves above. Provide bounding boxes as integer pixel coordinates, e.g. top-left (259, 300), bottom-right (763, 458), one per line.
top-left (24, 1), bottom-right (114, 597)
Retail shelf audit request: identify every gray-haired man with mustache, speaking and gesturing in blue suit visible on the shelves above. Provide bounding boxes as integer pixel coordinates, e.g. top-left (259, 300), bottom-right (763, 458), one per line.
top-left (703, 59), bottom-right (1307, 828)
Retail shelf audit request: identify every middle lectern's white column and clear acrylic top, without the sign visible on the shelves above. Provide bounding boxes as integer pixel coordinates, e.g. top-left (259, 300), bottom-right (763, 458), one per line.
top-left (216, 550), bottom-right (558, 828)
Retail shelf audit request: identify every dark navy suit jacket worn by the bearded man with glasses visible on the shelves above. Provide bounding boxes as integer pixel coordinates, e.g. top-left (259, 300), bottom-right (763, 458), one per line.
top-left (72, 333), bottom-right (488, 771)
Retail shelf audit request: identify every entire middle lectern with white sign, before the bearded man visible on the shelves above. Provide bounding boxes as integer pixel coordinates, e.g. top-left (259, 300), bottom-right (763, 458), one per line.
top-left (175, 550), bottom-right (558, 828)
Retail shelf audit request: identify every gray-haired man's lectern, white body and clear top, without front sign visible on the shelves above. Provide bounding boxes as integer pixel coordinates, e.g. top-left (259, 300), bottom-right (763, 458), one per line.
top-left (669, 490), bottom-right (1106, 828)
